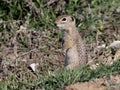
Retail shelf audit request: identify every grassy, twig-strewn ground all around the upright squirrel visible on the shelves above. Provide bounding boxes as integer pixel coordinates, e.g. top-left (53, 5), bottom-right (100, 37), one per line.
top-left (0, 0), bottom-right (120, 90)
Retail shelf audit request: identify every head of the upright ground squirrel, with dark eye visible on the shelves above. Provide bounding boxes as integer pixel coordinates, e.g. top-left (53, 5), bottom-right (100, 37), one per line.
top-left (55, 15), bottom-right (75, 30)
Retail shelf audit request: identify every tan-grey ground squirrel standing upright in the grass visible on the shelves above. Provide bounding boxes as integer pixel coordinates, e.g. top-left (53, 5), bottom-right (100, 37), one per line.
top-left (55, 15), bottom-right (88, 68)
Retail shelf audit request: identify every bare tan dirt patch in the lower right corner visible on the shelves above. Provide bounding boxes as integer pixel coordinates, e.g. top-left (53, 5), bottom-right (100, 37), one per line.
top-left (65, 75), bottom-right (120, 90)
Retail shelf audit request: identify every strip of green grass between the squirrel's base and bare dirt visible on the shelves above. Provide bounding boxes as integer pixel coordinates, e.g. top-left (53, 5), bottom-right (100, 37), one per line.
top-left (38, 60), bottom-right (120, 90)
